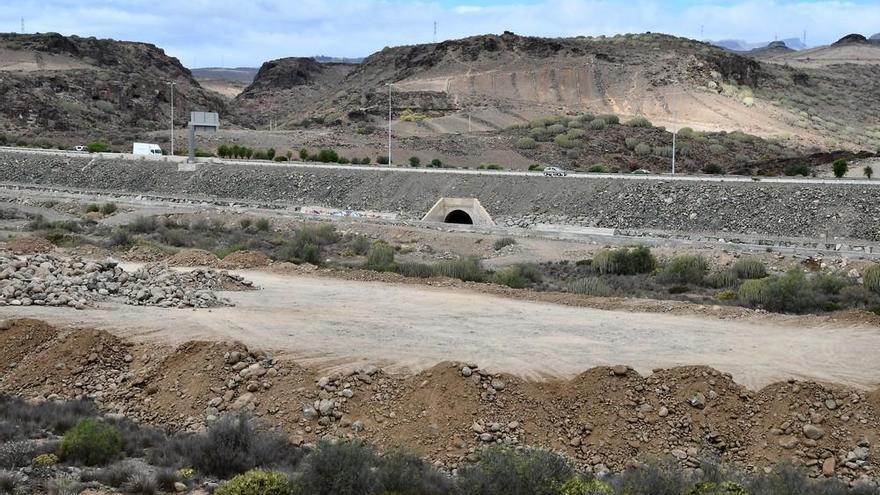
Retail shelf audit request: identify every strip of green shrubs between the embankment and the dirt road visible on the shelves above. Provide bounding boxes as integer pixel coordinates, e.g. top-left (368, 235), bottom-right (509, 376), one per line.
top-left (20, 213), bottom-right (880, 314)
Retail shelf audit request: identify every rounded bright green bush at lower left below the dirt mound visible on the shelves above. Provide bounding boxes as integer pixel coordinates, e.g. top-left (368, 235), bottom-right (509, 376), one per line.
top-left (58, 418), bottom-right (122, 466)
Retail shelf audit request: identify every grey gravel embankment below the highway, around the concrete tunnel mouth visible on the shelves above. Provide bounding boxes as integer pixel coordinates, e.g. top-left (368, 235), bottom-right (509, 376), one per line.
top-left (0, 153), bottom-right (880, 241)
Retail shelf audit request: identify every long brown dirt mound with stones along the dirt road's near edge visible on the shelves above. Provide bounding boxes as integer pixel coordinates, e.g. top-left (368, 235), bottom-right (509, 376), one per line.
top-left (0, 320), bottom-right (880, 479)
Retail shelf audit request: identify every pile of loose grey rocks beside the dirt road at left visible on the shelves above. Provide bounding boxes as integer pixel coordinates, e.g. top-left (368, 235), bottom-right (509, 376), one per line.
top-left (0, 254), bottom-right (252, 309)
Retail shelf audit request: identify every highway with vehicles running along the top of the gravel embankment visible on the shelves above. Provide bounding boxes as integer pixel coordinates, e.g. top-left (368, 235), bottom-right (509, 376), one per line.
top-left (0, 146), bottom-right (880, 187)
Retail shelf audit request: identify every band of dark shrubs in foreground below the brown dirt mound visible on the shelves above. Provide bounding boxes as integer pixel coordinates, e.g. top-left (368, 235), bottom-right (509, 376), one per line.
top-left (0, 396), bottom-right (880, 495)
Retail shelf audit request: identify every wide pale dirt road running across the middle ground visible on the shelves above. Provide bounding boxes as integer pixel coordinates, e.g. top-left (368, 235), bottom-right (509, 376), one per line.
top-left (0, 272), bottom-right (880, 388)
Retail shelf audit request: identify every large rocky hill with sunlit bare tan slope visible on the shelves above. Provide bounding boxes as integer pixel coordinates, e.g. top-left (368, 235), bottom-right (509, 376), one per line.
top-left (237, 32), bottom-right (880, 149)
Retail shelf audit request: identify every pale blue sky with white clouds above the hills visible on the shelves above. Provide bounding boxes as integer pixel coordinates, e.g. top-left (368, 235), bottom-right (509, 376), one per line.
top-left (0, 0), bottom-right (880, 67)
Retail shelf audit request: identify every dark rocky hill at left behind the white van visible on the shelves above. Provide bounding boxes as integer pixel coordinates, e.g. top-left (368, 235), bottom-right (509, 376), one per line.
top-left (0, 33), bottom-right (226, 142)
